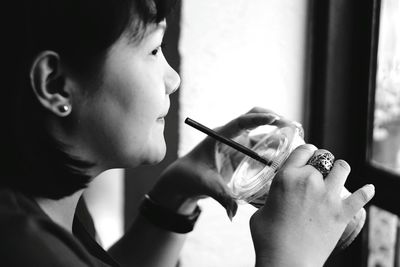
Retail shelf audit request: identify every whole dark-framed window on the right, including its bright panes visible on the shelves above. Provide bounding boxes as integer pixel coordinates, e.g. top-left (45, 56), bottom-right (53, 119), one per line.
top-left (308, 0), bottom-right (400, 267)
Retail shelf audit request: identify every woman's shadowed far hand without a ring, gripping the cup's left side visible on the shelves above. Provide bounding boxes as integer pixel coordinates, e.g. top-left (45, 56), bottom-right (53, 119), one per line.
top-left (150, 108), bottom-right (278, 218)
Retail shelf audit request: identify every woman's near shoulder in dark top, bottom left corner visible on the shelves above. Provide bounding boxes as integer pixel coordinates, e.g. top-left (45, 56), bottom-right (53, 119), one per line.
top-left (0, 189), bottom-right (96, 266)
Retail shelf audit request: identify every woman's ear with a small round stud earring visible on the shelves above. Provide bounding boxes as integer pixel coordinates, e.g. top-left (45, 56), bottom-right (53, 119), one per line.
top-left (30, 51), bottom-right (71, 117)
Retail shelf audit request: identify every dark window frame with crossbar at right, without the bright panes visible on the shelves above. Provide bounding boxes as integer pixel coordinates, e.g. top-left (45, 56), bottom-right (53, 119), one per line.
top-left (305, 0), bottom-right (400, 267)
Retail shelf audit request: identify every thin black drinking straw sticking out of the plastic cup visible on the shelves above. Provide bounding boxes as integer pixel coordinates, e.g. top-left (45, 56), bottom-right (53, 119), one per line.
top-left (185, 118), bottom-right (268, 165)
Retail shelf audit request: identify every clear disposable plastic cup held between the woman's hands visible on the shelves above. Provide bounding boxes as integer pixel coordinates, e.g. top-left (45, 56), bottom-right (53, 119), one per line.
top-left (215, 119), bottom-right (366, 250)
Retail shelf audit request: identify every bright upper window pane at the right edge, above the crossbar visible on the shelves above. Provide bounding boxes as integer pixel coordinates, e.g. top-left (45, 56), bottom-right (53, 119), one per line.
top-left (372, 0), bottom-right (400, 174)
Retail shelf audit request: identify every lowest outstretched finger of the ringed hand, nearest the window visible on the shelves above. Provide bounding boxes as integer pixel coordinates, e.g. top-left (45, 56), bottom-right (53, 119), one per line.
top-left (344, 184), bottom-right (375, 221)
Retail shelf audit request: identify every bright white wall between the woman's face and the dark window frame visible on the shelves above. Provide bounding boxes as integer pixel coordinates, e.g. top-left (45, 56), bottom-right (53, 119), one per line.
top-left (178, 0), bottom-right (308, 267)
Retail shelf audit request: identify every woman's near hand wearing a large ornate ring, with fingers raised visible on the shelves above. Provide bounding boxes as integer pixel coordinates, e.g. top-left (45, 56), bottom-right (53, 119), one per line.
top-left (250, 145), bottom-right (374, 266)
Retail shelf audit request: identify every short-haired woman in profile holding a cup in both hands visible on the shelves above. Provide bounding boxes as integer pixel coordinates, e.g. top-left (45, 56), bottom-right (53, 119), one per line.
top-left (0, 0), bottom-right (373, 266)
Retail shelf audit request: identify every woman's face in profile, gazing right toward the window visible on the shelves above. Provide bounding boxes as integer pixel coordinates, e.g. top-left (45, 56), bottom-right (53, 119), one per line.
top-left (72, 22), bottom-right (180, 171)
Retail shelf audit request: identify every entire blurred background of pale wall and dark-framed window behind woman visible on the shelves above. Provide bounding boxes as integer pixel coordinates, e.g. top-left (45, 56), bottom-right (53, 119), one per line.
top-left (85, 0), bottom-right (400, 267)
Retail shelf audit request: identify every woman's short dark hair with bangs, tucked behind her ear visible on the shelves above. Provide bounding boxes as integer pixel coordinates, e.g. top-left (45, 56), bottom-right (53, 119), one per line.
top-left (0, 0), bottom-right (175, 199)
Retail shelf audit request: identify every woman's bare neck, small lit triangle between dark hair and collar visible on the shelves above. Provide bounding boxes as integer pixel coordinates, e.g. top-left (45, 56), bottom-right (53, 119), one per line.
top-left (35, 190), bottom-right (83, 233)
